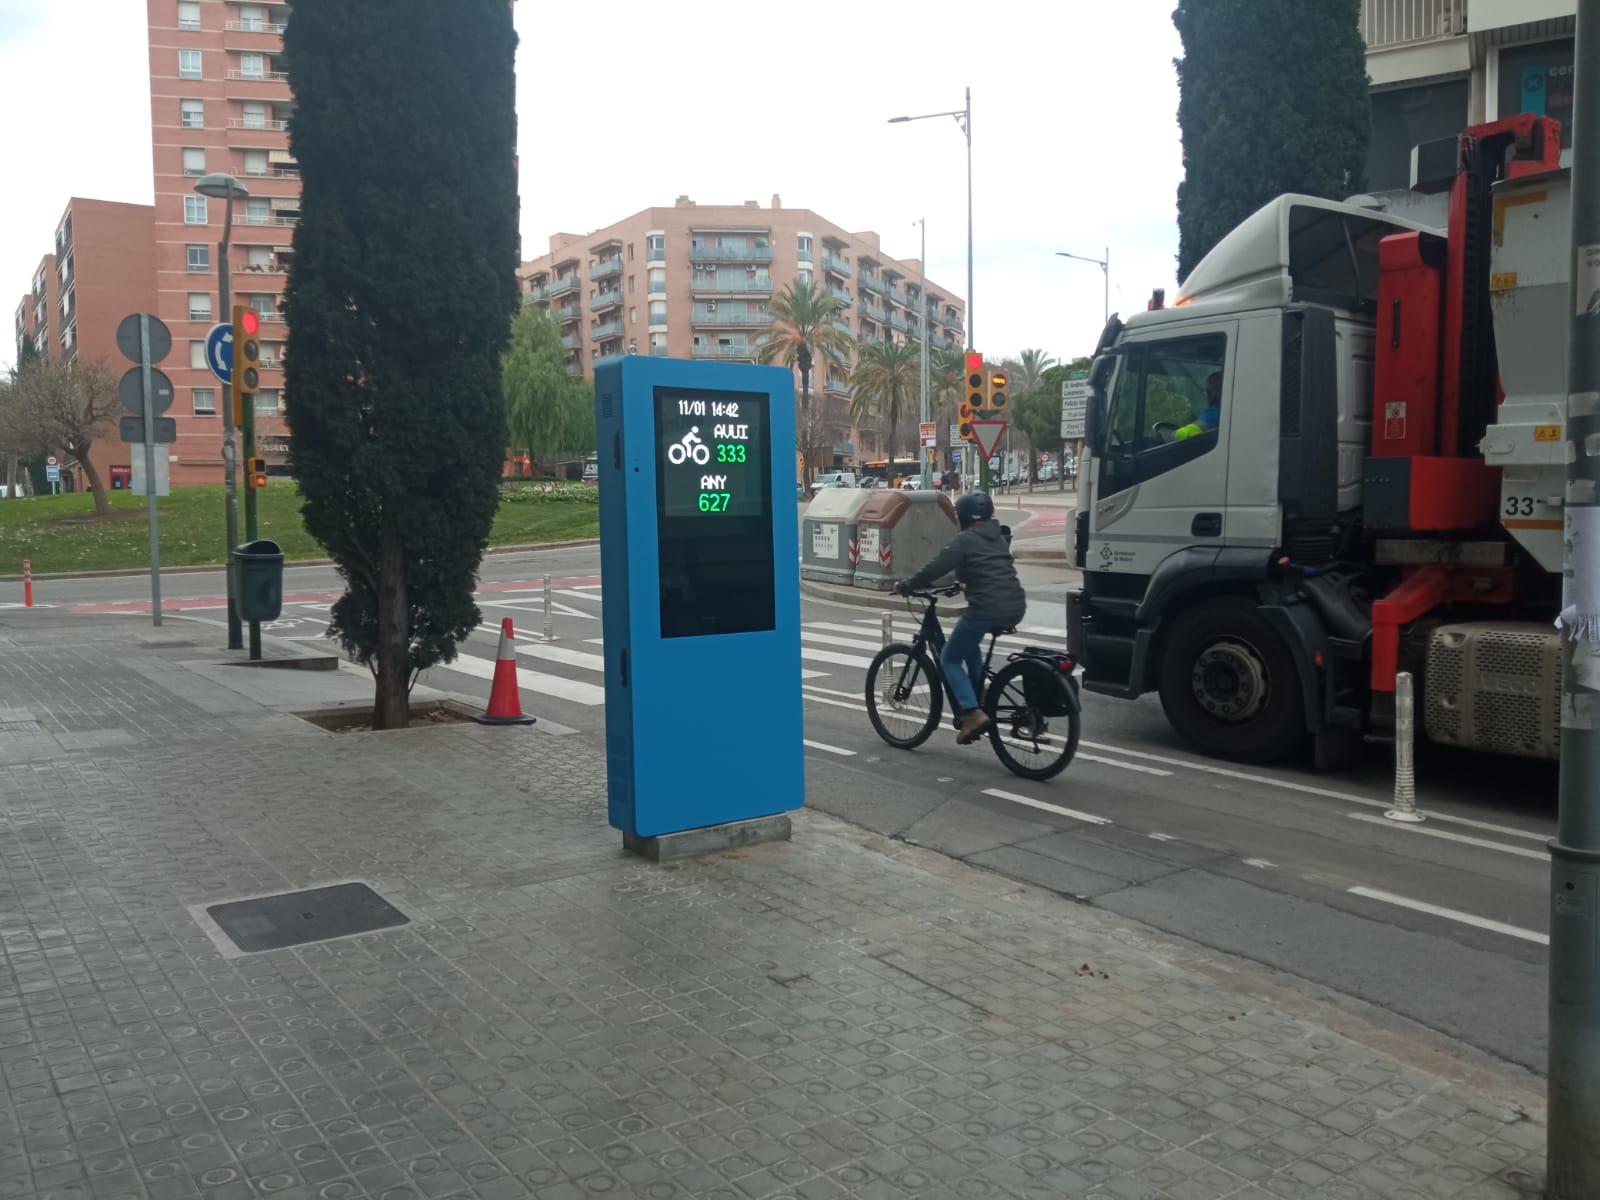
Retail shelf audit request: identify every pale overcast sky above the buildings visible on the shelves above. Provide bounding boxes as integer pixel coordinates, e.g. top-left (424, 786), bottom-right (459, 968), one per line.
top-left (0, 0), bottom-right (1181, 376)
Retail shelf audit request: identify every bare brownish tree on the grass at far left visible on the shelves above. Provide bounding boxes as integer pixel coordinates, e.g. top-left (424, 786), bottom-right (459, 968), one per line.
top-left (0, 358), bottom-right (122, 515)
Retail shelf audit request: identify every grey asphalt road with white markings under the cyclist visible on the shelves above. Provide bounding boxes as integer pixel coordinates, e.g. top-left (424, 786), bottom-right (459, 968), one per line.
top-left (37, 526), bottom-right (1555, 1072)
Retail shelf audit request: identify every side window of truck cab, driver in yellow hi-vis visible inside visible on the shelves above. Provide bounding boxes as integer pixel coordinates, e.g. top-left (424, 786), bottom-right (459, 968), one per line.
top-left (1106, 333), bottom-right (1227, 494)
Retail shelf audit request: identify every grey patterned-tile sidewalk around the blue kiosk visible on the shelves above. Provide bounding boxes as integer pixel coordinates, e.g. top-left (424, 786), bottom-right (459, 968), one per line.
top-left (0, 611), bottom-right (1544, 1200)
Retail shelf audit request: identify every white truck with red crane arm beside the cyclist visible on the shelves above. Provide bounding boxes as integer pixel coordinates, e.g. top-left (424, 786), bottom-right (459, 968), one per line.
top-left (1069, 115), bottom-right (1570, 768)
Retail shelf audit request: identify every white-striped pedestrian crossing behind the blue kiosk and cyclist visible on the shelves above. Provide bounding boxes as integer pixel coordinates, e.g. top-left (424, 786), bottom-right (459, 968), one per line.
top-left (276, 586), bottom-right (1066, 728)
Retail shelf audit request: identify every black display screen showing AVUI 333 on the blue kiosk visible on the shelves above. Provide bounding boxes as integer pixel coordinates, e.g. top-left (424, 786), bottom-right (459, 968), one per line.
top-left (654, 387), bottom-right (776, 637)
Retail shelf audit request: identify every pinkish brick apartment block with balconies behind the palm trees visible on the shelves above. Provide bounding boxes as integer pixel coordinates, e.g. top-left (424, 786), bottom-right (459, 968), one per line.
top-left (518, 195), bottom-right (966, 464)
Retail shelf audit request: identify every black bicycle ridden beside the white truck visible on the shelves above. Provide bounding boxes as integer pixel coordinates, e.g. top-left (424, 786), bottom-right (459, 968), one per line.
top-left (867, 584), bottom-right (1083, 779)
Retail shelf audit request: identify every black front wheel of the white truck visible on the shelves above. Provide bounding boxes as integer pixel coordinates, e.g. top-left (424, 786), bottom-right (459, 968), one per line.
top-left (1158, 595), bottom-right (1306, 763)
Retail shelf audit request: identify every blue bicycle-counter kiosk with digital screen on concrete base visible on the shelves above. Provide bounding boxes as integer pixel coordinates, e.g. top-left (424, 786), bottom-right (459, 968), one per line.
top-left (595, 355), bottom-right (805, 858)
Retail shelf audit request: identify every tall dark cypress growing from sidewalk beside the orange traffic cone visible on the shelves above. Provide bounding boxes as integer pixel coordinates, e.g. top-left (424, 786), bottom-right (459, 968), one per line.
top-left (283, 0), bottom-right (518, 728)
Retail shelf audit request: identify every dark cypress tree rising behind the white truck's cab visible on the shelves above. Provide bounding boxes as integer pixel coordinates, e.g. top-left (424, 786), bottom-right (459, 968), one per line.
top-left (1173, 0), bottom-right (1371, 278)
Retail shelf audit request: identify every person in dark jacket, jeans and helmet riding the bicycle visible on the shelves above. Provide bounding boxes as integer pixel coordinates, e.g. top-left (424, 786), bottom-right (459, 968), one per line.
top-left (894, 491), bottom-right (1027, 746)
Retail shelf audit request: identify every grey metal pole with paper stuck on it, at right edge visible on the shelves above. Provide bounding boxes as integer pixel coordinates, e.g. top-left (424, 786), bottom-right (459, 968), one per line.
top-left (1546, 0), bottom-right (1600, 1200)
